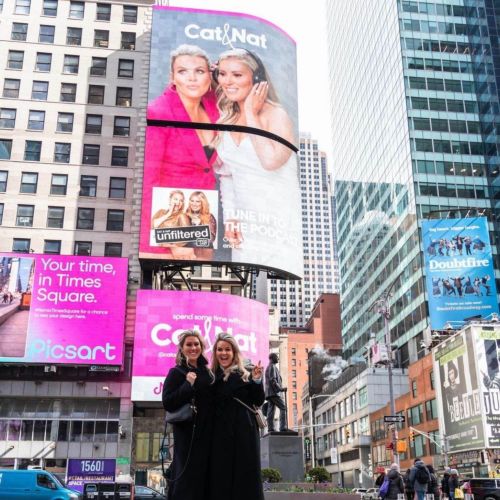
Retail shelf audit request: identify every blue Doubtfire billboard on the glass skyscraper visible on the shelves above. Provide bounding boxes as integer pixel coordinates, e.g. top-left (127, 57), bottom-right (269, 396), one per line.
top-left (422, 217), bottom-right (498, 330)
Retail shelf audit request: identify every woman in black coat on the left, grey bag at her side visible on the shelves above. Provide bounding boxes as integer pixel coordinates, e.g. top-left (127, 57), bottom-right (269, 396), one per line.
top-left (162, 331), bottom-right (213, 500)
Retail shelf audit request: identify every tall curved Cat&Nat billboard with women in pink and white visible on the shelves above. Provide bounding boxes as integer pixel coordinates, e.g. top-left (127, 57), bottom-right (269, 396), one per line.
top-left (139, 6), bottom-right (302, 277)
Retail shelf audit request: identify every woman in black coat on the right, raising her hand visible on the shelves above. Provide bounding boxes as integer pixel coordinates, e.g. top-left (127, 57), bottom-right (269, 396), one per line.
top-left (208, 334), bottom-right (264, 500)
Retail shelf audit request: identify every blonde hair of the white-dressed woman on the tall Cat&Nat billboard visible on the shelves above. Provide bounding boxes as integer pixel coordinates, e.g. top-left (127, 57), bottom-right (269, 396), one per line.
top-left (215, 49), bottom-right (279, 123)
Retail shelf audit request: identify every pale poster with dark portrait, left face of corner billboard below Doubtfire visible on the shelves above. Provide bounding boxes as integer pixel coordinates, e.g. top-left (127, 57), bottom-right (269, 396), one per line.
top-left (434, 333), bottom-right (484, 452)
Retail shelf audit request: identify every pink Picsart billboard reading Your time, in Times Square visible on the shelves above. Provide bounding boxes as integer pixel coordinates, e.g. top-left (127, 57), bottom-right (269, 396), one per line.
top-left (0, 253), bottom-right (128, 365)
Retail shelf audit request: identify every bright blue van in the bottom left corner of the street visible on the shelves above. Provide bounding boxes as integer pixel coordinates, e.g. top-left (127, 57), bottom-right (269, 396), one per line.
top-left (0, 469), bottom-right (82, 500)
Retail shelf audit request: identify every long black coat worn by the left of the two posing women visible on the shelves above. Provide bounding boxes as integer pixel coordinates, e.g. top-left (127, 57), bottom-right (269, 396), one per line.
top-left (162, 361), bottom-right (213, 500)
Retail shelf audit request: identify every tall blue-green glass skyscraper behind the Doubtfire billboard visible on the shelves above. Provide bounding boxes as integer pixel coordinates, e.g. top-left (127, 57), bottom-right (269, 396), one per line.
top-left (327, 0), bottom-right (500, 366)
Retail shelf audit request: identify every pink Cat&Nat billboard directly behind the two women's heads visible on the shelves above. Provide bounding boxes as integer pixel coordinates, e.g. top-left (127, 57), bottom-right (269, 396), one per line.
top-left (132, 290), bottom-right (269, 401)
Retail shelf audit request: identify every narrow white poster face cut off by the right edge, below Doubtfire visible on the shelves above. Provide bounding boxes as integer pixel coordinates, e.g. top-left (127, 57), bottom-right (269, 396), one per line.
top-left (475, 327), bottom-right (500, 448)
